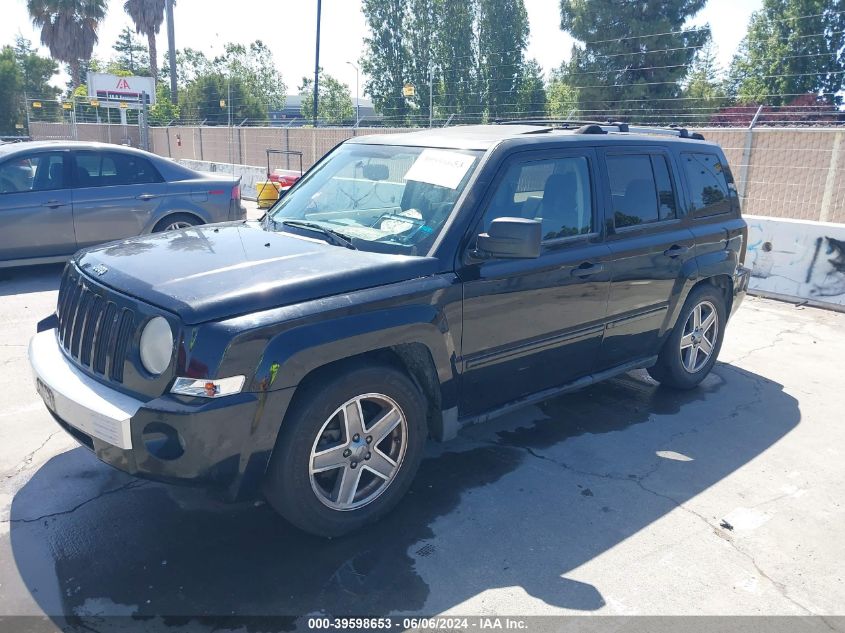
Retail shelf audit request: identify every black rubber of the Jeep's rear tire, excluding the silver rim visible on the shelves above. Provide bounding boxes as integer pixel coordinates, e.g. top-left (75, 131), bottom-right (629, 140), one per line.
top-left (651, 285), bottom-right (727, 389)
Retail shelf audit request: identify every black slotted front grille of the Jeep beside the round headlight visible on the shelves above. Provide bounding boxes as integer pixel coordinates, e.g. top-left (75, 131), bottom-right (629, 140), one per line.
top-left (56, 272), bottom-right (135, 382)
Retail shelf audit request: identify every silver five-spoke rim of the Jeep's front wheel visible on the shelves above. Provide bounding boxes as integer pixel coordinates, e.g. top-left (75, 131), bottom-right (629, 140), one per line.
top-left (309, 393), bottom-right (408, 510)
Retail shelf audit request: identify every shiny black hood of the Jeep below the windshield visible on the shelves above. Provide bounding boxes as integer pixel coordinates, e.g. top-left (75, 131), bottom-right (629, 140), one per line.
top-left (76, 222), bottom-right (437, 324)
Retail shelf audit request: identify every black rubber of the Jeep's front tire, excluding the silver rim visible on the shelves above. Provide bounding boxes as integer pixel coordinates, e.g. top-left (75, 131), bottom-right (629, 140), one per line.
top-left (264, 365), bottom-right (427, 537)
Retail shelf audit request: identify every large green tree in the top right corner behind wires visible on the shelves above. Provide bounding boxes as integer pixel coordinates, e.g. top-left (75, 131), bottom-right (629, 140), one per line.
top-left (728, 0), bottom-right (845, 105)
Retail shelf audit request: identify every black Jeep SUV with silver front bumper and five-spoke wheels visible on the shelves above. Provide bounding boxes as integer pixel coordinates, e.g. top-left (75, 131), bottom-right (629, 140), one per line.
top-left (29, 124), bottom-right (748, 536)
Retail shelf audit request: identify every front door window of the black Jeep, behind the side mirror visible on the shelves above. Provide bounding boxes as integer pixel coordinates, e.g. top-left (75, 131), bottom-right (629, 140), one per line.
top-left (483, 156), bottom-right (594, 240)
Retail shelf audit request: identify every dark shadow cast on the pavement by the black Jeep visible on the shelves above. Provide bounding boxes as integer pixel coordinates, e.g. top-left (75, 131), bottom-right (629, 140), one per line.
top-left (6, 364), bottom-right (800, 628)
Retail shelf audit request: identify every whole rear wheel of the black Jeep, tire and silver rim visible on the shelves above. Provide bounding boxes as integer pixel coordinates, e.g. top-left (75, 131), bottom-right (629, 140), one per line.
top-left (648, 284), bottom-right (727, 389)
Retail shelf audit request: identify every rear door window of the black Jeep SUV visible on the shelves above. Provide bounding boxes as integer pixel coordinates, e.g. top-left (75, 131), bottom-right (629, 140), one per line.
top-left (607, 154), bottom-right (677, 228)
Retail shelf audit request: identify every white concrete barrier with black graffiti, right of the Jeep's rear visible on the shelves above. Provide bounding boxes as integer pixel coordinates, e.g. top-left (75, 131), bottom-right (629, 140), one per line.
top-left (745, 215), bottom-right (845, 311)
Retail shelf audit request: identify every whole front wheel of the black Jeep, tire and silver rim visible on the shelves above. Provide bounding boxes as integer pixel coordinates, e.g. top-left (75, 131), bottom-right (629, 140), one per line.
top-left (264, 364), bottom-right (427, 537)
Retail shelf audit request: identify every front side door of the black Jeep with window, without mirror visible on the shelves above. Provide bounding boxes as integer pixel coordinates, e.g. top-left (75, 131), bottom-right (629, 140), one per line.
top-left (459, 149), bottom-right (611, 417)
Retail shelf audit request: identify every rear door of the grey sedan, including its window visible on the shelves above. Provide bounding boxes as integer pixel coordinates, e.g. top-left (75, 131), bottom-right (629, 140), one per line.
top-left (73, 151), bottom-right (167, 248)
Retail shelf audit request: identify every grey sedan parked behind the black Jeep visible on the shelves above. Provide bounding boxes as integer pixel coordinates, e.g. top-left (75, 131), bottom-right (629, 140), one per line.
top-left (0, 142), bottom-right (246, 268)
